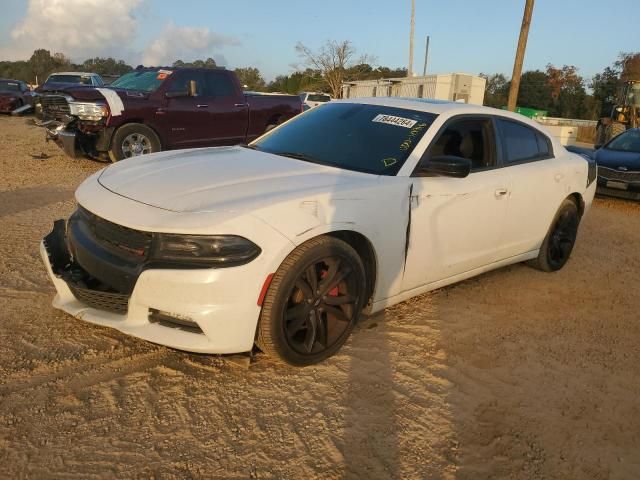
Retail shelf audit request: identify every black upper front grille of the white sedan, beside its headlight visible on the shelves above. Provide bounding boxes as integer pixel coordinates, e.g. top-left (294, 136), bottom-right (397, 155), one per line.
top-left (78, 207), bottom-right (153, 260)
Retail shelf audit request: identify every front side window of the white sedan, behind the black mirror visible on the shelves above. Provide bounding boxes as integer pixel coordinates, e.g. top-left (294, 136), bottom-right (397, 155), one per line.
top-left (429, 118), bottom-right (496, 171)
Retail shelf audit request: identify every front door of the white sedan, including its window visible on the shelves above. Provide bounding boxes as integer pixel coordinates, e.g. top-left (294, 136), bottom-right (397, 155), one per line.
top-left (403, 116), bottom-right (508, 291)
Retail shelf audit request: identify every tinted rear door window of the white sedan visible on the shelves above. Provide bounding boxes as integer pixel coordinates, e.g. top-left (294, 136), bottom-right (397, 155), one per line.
top-left (497, 119), bottom-right (551, 164)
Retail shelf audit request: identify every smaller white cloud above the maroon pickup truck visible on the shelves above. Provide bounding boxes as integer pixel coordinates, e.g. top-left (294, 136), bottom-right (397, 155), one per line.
top-left (142, 23), bottom-right (240, 65)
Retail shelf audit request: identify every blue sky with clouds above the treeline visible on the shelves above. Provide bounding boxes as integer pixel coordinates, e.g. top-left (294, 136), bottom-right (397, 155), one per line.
top-left (0, 0), bottom-right (640, 80)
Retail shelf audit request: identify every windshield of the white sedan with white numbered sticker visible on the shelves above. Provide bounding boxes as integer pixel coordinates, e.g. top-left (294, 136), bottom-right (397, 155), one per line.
top-left (251, 102), bottom-right (436, 175)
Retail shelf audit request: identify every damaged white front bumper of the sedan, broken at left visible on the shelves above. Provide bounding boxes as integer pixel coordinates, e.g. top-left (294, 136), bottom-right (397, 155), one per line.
top-left (40, 220), bottom-right (260, 353)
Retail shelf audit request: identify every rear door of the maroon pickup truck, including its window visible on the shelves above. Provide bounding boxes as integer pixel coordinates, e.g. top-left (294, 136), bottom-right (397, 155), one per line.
top-left (205, 70), bottom-right (249, 145)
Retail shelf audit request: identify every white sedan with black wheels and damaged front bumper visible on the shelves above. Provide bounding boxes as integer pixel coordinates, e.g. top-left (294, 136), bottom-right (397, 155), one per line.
top-left (41, 98), bottom-right (596, 365)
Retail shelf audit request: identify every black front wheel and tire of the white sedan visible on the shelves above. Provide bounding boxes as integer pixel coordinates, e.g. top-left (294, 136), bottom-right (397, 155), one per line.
top-left (256, 236), bottom-right (366, 366)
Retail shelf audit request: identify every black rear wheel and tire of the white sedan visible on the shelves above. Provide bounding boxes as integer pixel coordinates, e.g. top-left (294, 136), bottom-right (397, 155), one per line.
top-left (528, 199), bottom-right (580, 272)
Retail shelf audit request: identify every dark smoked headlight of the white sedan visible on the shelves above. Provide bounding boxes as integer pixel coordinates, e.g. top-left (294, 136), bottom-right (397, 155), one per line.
top-left (152, 233), bottom-right (261, 266)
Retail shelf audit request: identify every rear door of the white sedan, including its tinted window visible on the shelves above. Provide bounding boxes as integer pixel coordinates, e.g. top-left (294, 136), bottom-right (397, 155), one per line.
top-left (496, 117), bottom-right (570, 258)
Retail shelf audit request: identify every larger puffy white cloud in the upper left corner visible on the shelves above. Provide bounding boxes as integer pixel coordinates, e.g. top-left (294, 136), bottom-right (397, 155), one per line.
top-left (0, 0), bottom-right (141, 60)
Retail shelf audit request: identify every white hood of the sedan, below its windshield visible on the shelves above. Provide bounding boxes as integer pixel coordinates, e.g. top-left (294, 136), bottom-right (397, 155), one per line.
top-left (98, 147), bottom-right (377, 212)
